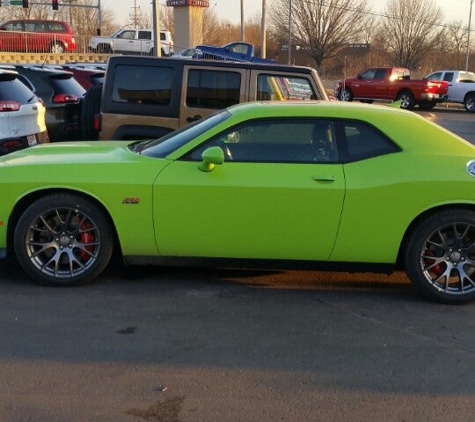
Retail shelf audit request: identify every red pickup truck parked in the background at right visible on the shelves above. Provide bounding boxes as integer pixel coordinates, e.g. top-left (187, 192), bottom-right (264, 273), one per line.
top-left (335, 67), bottom-right (448, 110)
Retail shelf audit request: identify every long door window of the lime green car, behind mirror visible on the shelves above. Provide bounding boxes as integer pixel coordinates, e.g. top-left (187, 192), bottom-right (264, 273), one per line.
top-left (189, 118), bottom-right (338, 164)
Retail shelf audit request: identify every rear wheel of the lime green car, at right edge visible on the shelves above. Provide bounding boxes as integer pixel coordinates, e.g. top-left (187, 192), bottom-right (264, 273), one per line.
top-left (404, 209), bottom-right (475, 304)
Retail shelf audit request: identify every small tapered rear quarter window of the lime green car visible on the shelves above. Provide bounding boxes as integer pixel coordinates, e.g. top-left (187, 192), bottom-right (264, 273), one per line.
top-left (338, 121), bottom-right (401, 162)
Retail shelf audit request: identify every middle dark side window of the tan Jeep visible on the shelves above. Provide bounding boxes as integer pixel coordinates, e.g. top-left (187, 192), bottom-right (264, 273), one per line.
top-left (186, 69), bottom-right (241, 109)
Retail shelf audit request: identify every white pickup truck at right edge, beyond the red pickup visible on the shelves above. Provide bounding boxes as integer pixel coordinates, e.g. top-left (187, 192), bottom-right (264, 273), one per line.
top-left (424, 70), bottom-right (475, 113)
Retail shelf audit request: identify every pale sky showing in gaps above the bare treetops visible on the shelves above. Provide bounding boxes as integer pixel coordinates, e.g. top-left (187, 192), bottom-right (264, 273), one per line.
top-left (100, 0), bottom-right (475, 28)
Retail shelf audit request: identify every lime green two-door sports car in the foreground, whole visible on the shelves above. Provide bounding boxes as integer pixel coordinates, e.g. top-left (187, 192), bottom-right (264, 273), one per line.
top-left (0, 101), bottom-right (475, 303)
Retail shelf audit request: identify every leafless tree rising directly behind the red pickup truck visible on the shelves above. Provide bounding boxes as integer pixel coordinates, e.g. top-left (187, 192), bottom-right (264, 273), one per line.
top-left (382, 0), bottom-right (443, 69)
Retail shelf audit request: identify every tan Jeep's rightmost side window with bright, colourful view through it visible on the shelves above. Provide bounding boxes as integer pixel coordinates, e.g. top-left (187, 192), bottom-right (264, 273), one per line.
top-left (256, 74), bottom-right (317, 101)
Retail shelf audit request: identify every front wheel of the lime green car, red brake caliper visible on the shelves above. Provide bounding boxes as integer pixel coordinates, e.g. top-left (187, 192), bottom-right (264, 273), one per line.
top-left (14, 193), bottom-right (113, 286)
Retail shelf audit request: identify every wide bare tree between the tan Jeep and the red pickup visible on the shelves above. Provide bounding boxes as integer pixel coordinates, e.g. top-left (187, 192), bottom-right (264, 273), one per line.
top-left (269, 0), bottom-right (369, 67)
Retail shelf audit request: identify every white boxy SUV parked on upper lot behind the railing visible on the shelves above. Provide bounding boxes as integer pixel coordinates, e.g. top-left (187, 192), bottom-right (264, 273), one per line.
top-left (88, 28), bottom-right (174, 56)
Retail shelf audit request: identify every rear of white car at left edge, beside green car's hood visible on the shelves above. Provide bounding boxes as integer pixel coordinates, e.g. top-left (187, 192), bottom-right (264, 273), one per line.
top-left (0, 69), bottom-right (49, 155)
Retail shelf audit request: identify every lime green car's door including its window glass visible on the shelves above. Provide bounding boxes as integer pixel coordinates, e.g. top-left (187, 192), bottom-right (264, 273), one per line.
top-left (153, 118), bottom-right (345, 260)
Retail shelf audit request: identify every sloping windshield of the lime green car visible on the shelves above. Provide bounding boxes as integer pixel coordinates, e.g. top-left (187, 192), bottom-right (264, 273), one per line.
top-left (141, 110), bottom-right (231, 158)
